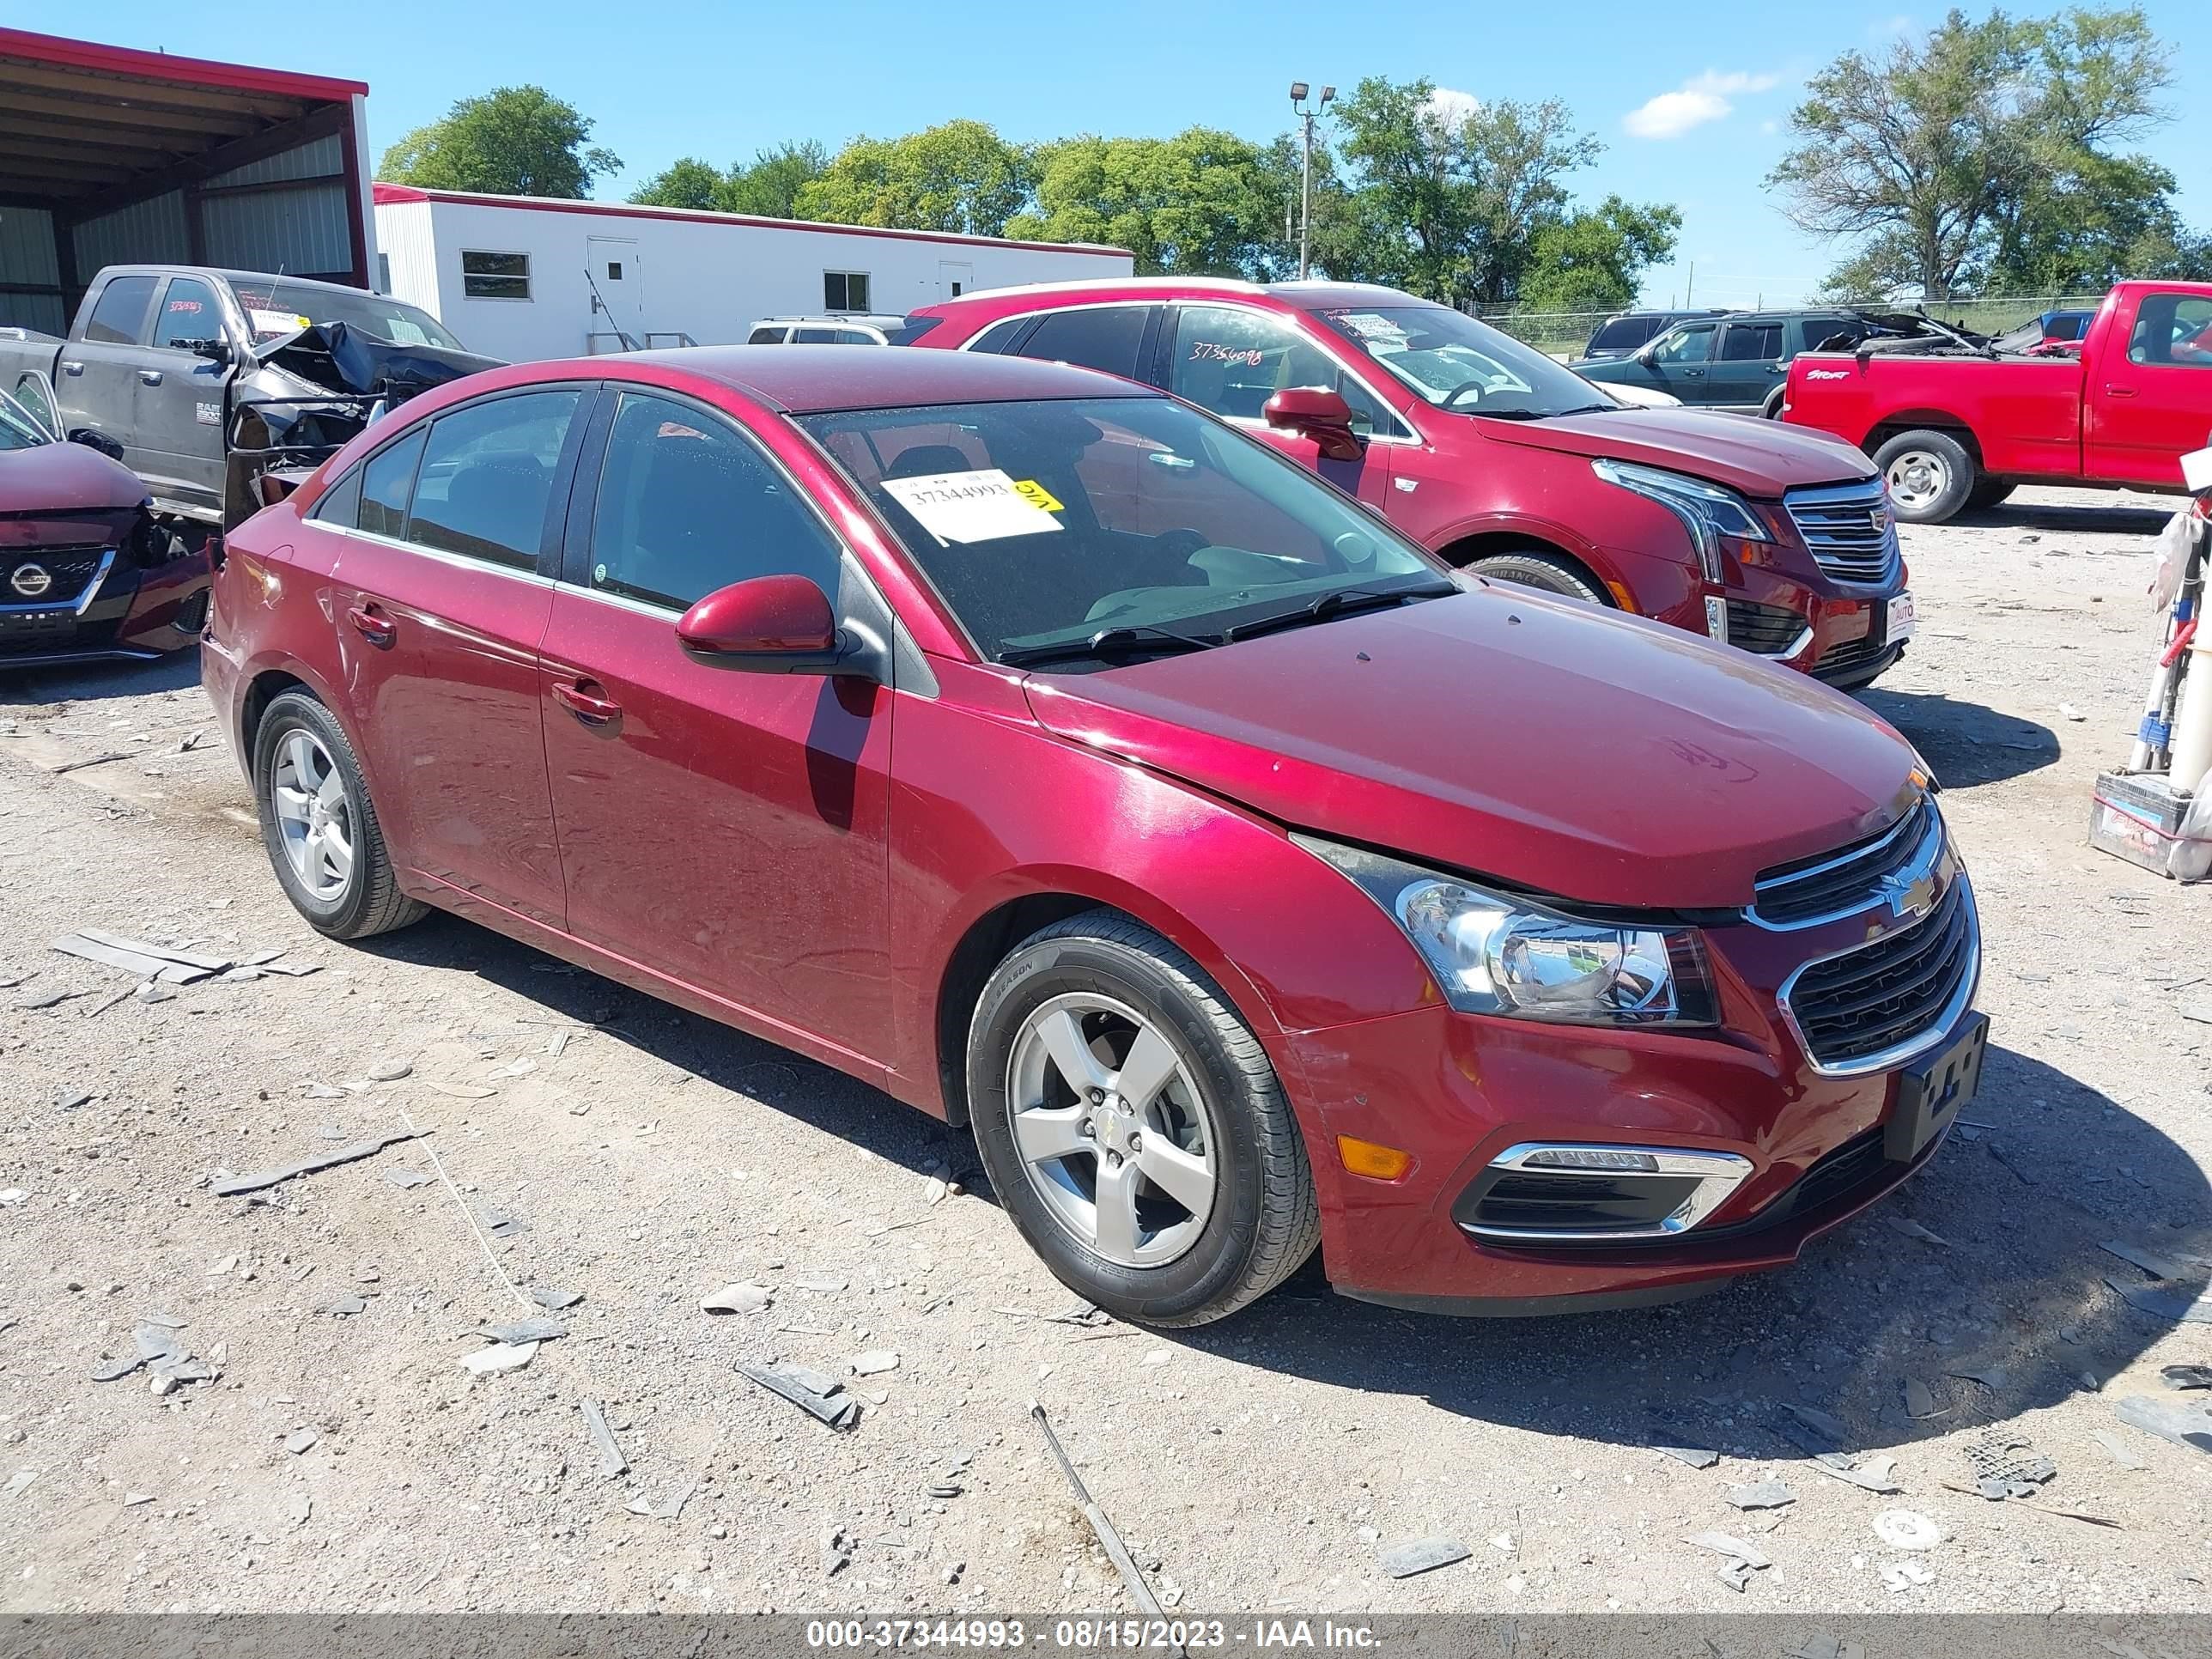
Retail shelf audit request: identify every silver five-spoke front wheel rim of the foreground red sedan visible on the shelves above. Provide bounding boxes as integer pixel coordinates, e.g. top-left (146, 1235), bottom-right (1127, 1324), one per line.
top-left (1006, 991), bottom-right (1221, 1267)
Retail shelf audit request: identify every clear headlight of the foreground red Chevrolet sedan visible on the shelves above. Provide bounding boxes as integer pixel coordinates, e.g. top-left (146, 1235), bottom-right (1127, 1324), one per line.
top-left (1291, 836), bottom-right (1714, 1026)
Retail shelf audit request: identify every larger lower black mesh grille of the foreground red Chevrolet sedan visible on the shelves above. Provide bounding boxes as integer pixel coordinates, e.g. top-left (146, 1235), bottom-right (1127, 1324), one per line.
top-left (1781, 876), bottom-right (1980, 1075)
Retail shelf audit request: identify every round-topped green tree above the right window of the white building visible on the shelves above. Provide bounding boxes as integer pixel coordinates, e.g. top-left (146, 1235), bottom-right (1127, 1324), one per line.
top-left (796, 122), bottom-right (1029, 237)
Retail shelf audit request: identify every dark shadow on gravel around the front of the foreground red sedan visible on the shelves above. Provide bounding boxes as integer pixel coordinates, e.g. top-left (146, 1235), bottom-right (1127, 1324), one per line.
top-left (1164, 1044), bottom-right (2212, 1480)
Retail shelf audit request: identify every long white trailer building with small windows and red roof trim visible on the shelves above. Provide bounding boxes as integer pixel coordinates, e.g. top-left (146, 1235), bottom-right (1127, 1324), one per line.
top-left (376, 184), bottom-right (1134, 362)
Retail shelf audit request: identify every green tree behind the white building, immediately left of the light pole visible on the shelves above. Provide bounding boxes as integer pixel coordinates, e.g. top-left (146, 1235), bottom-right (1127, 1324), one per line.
top-left (1006, 126), bottom-right (1285, 276)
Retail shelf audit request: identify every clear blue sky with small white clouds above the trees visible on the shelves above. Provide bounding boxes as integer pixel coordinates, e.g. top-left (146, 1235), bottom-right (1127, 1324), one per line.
top-left (47, 0), bottom-right (2212, 305)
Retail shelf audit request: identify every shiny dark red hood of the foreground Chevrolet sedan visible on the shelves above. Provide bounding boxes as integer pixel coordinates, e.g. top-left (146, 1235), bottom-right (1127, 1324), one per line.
top-left (1026, 584), bottom-right (1916, 909)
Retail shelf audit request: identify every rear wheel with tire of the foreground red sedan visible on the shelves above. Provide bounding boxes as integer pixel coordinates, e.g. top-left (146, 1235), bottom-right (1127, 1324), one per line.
top-left (254, 690), bottom-right (425, 940)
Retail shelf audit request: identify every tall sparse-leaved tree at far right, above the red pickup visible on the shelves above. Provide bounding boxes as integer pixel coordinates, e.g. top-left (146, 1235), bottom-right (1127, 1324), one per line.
top-left (1767, 7), bottom-right (2174, 301)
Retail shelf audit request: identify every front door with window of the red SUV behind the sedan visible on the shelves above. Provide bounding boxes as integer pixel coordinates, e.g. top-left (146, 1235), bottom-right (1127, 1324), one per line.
top-left (1168, 305), bottom-right (1395, 511)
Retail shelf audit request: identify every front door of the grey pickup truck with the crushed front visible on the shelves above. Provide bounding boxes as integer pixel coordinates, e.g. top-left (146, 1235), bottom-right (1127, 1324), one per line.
top-left (137, 276), bottom-right (243, 511)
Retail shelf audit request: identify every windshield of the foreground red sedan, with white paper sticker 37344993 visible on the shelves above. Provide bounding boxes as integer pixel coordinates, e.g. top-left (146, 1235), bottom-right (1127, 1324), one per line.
top-left (799, 398), bottom-right (1458, 671)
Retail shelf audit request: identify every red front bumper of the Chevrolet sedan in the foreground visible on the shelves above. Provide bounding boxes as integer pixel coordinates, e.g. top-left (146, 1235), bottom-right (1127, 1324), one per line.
top-left (1281, 878), bottom-right (1982, 1314)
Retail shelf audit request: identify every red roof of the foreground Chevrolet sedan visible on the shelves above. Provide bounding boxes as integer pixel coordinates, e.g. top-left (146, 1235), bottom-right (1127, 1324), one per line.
top-left (592, 345), bottom-right (1159, 414)
